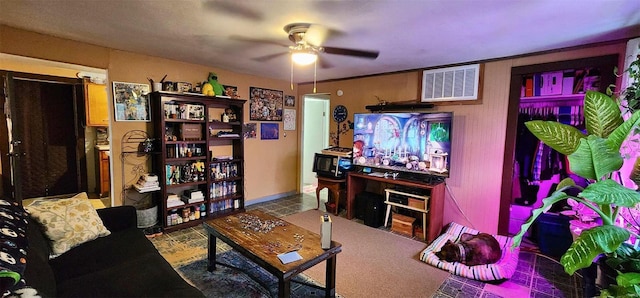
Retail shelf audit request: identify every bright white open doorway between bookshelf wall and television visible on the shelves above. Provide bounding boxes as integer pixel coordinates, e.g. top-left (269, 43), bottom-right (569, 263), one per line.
top-left (300, 94), bottom-right (330, 193)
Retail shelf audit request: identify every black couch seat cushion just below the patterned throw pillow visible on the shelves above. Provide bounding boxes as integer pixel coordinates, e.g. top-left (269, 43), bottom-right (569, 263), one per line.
top-left (49, 228), bottom-right (159, 283)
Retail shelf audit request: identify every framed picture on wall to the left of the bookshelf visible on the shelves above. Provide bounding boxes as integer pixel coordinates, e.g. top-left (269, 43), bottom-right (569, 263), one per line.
top-left (113, 82), bottom-right (151, 122)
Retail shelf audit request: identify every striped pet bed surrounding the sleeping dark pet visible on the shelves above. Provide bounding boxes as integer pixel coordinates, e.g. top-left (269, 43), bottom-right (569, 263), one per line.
top-left (420, 222), bottom-right (520, 281)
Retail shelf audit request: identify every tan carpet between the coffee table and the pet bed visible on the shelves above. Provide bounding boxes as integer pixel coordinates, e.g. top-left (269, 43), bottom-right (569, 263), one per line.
top-left (283, 210), bottom-right (450, 297)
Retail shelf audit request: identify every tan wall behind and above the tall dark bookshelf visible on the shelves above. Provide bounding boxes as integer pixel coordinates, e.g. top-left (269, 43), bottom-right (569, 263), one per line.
top-left (0, 26), bottom-right (300, 205)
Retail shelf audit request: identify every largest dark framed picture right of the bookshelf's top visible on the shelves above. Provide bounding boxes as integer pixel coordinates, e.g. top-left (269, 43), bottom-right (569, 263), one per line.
top-left (249, 87), bottom-right (284, 121)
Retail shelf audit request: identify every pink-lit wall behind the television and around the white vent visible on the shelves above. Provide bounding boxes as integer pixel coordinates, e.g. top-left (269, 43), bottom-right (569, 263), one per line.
top-left (298, 42), bottom-right (625, 233)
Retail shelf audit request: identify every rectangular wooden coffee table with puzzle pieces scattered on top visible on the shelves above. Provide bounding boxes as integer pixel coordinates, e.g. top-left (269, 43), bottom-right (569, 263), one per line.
top-left (203, 210), bottom-right (342, 297)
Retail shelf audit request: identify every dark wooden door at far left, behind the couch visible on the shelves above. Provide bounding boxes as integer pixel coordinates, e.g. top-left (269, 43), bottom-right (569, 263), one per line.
top-left (3, 73), bottom-right (87, 200)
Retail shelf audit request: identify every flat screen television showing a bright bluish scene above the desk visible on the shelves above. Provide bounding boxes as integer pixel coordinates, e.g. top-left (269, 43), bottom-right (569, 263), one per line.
top-left (353, 112), bottom-right (453, 179)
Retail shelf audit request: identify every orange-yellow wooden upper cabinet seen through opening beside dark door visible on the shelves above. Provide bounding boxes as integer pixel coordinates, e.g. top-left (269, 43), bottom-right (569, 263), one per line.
top-left (84, 82), bottom-right (109, 126)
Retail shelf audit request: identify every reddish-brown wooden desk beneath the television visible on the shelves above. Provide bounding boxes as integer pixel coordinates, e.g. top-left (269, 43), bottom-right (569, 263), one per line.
top-left (347, 172), bottom-right (445, 242)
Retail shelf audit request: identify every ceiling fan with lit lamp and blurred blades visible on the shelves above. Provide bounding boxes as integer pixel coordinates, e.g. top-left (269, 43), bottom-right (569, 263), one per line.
top-left (236, 23), bottom-right (380, 68)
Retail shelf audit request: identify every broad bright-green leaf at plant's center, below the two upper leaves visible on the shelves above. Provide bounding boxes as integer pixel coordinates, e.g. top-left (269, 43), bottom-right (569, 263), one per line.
top-left (568, 135), bottom-right (623, 180)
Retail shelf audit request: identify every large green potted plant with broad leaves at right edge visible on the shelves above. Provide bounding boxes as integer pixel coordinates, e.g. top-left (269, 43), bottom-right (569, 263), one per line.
top-left (514, 91), bottom-right (640, 295)
